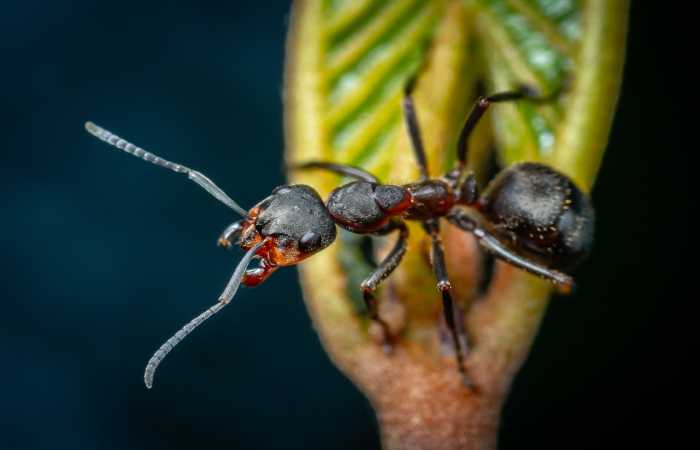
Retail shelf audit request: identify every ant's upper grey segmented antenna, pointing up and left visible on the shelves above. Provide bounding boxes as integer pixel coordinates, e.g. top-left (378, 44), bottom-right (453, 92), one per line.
top-left (85, 122), bottom-right (248, 217)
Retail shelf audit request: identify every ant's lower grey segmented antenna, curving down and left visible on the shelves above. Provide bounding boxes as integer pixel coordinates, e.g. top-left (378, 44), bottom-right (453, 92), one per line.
top-left (143, 240), bottom-right (267, 389)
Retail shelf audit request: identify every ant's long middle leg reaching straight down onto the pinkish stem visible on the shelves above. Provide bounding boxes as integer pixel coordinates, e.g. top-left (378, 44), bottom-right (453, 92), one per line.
top-left (423, 219), bottom-right (474, 389)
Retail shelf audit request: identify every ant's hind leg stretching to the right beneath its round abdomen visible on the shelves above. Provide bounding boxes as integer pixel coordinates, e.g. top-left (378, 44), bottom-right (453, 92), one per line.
top-left (447, 211), bottom-right (574, 293)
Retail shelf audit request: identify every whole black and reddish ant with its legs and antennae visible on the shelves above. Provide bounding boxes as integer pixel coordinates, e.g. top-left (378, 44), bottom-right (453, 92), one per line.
top-left (85, 81), bottom-right (594, 388)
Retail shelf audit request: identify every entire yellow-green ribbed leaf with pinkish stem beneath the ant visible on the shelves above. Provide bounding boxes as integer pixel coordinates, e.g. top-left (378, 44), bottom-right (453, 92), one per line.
top-left (285, 0), bottom-right (629, 448)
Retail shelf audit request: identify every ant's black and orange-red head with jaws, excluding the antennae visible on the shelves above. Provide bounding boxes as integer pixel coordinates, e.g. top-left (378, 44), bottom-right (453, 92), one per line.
top-left (219, 184), bottom-right (336, 266)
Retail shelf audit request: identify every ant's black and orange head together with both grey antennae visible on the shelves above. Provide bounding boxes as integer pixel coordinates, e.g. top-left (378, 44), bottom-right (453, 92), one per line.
top-left (85, 122), bottom-right (335, 388)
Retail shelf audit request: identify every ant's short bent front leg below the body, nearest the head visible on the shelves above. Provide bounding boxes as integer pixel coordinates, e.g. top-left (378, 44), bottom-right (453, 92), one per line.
top-left (360, 220), bottom-right (408, 352)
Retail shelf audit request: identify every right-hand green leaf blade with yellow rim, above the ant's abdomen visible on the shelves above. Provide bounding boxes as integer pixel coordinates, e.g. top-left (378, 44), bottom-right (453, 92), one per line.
top-left (477, 0), bottom-right (627, 190)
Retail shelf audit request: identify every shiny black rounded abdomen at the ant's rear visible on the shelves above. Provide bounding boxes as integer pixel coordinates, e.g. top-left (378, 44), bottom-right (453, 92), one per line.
top-left (478, 162), bottom-right (595, 270)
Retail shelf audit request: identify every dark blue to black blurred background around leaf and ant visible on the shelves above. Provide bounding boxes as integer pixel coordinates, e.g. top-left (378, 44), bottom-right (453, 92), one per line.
top-left (0, 0), bottom-right (694, 450)
